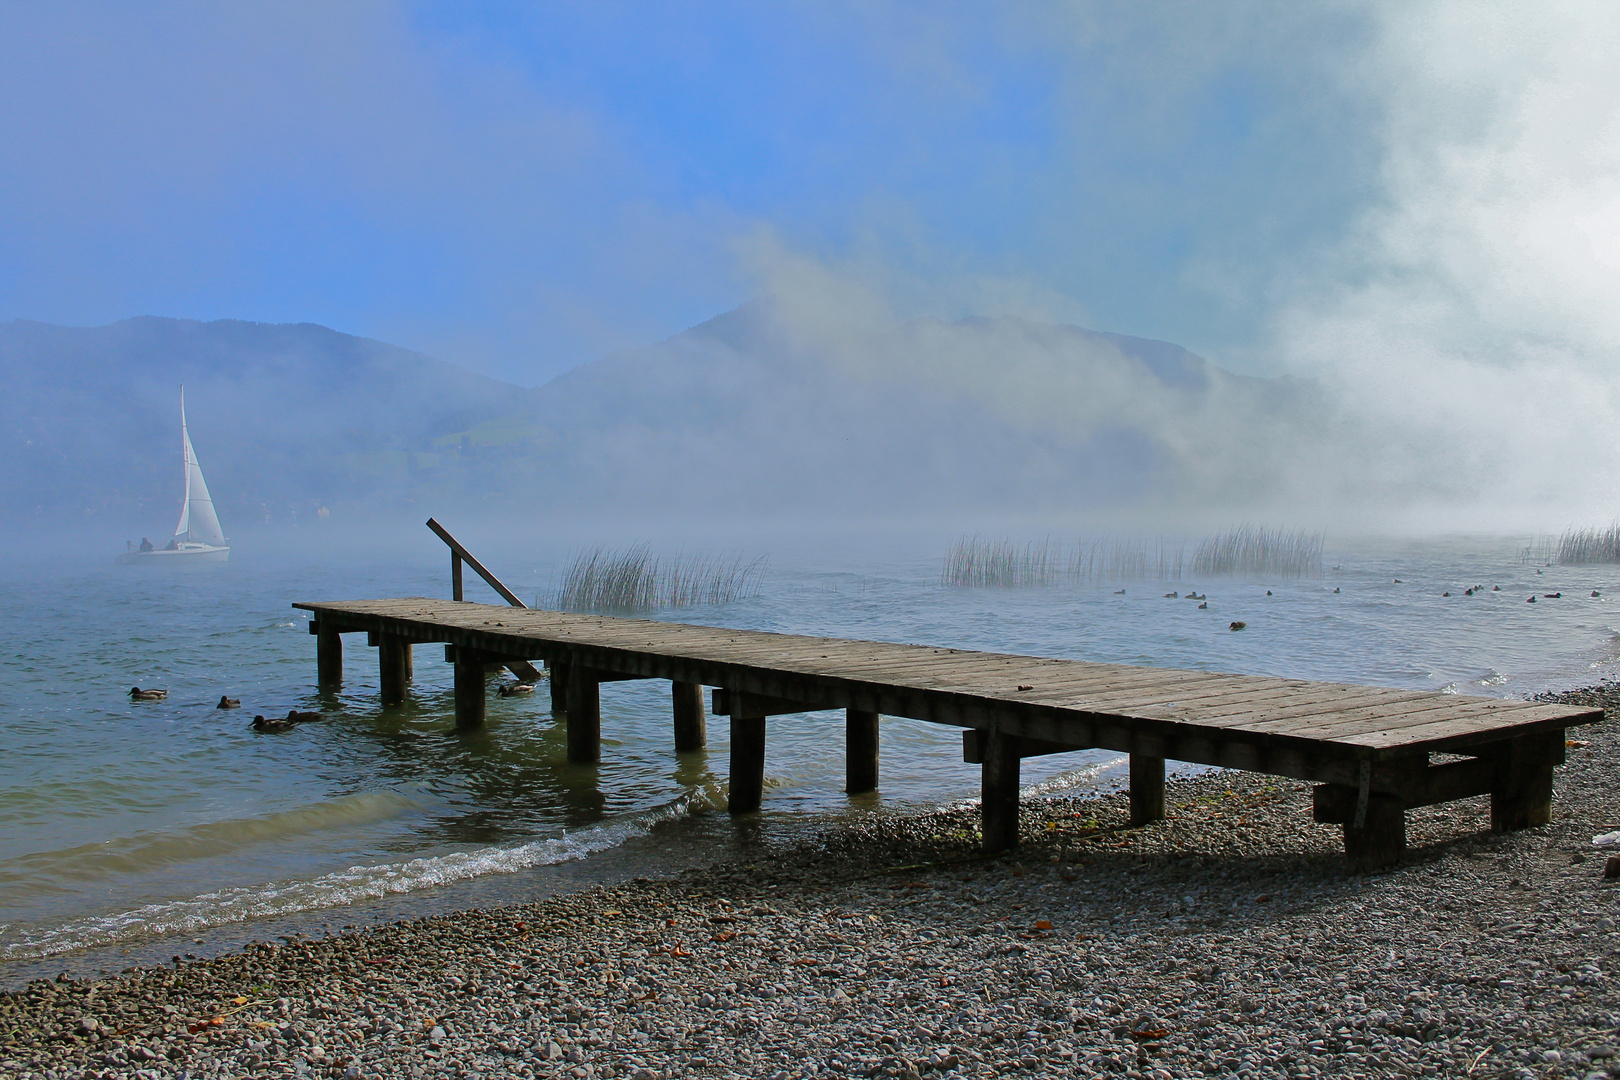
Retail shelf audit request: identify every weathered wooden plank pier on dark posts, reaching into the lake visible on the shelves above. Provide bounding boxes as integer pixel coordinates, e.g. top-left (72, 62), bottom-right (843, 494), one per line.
top-left (293, 597), bottom-right (1602, 870)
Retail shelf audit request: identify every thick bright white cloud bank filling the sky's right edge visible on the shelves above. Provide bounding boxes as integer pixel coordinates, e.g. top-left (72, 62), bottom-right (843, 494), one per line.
top-left (1275, 0), bottom-right (1620, 528)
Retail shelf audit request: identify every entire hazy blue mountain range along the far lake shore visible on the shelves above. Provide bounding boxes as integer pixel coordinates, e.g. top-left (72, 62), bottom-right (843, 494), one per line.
top-left (0, 301), bottom-right (1325, 531)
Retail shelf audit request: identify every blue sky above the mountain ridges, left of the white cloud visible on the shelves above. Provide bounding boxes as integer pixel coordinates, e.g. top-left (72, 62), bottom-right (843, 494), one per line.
top-left (0, 3), bottom-right (1383, 384)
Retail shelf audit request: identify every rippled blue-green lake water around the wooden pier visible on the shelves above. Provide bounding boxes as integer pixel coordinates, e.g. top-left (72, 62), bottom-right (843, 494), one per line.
top-left (0, 536), bottom-right (1620, 981)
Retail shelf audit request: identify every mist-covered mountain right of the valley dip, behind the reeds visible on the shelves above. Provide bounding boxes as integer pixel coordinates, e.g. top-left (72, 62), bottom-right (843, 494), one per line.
top-left (511, 301), bottom-right (1320, 513)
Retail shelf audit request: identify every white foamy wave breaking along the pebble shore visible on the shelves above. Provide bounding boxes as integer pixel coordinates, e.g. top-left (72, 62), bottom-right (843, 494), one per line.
top-left (0, 797), bottom-right (698, 960)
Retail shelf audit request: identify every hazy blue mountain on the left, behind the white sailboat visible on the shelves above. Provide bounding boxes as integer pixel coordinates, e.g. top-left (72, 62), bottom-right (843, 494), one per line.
top-left (0, 317), bottom-right (527, 526)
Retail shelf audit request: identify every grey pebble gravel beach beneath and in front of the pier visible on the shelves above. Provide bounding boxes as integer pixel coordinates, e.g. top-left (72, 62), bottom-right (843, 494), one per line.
top-left (0, 685), bottom-right (1620, 1080)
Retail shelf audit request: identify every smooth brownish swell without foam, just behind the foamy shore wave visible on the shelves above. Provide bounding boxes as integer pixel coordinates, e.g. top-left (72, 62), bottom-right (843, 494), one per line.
top-left (0, 792), bottom-right (418, 895)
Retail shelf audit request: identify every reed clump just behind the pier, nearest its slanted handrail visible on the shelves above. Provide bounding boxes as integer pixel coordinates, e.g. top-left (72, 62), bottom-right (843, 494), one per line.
top-left (554, 544), bottom-right (766, 612)
